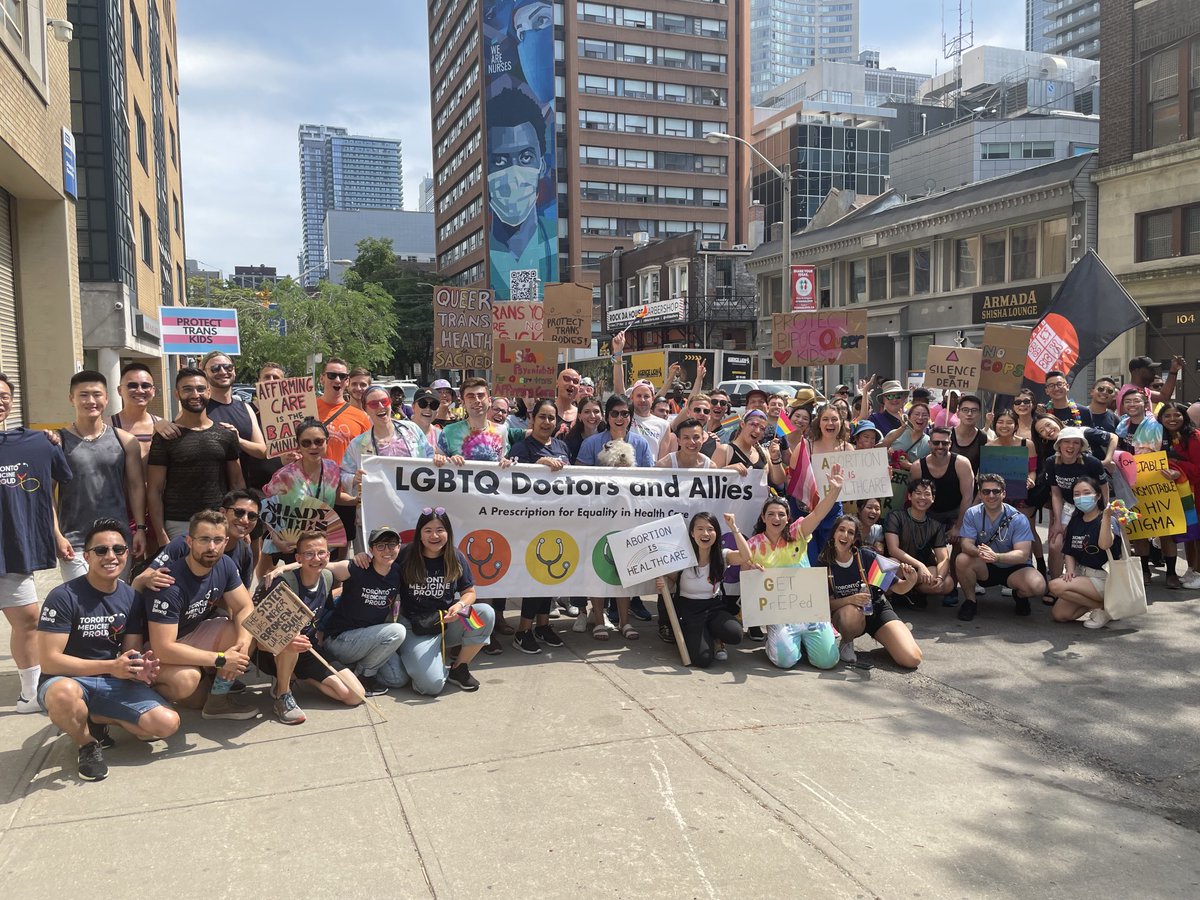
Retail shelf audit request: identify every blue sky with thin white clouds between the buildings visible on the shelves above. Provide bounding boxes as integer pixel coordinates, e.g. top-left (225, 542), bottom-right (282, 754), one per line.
top-left (176, 0), bottom-right (1025, 275)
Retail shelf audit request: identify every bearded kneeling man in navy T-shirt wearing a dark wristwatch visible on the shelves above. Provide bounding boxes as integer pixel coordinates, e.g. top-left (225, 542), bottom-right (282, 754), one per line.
top-left (143, 510), bottom-right (259, 719)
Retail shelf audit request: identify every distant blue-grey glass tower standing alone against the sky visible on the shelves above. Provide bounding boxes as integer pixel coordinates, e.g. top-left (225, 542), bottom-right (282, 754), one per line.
top-left (298, 125), bottom-right (404, 287)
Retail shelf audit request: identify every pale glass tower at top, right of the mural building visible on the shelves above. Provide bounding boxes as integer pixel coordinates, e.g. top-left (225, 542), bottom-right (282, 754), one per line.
top-left (750, 0), bottom-right (859, 103)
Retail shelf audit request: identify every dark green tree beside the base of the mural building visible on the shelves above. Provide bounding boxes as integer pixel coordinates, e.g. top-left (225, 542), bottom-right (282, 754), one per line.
top-left (344, 238), bottom-right (440, 384)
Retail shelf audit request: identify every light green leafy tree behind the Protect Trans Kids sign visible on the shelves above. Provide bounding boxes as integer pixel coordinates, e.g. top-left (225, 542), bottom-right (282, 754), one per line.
top-left (188, 278), bottom-right (396, 380)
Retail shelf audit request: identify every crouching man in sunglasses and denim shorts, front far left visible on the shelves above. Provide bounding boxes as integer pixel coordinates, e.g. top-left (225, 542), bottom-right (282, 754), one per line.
top-left (37, 518), bottom-right (179, 781)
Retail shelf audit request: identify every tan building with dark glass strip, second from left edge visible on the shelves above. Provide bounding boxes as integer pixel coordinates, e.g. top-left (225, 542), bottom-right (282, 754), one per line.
top-left (67, 0), bottom-right (186, 412)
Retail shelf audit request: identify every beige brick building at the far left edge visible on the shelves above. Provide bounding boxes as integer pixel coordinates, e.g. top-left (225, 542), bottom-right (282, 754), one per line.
top-left (0, 0), bottom-right (83, 428)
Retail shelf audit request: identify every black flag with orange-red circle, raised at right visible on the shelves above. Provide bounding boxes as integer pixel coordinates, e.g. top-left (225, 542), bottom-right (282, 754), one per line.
top-left (1025, 250), bottom-right (1146, 396)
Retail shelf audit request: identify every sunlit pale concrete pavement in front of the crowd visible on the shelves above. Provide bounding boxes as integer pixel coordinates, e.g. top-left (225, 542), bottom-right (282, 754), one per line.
top-left (0, 573), bottom-right (1200, 900)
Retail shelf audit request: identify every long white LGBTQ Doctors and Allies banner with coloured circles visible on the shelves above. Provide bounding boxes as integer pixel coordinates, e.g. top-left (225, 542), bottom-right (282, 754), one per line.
top-left (362, 456), bottom-right (767, 599)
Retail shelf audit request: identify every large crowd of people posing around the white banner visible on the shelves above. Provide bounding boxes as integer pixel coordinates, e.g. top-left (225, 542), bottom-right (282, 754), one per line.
top-left (0, 335), bottom-right (1200, 780)
